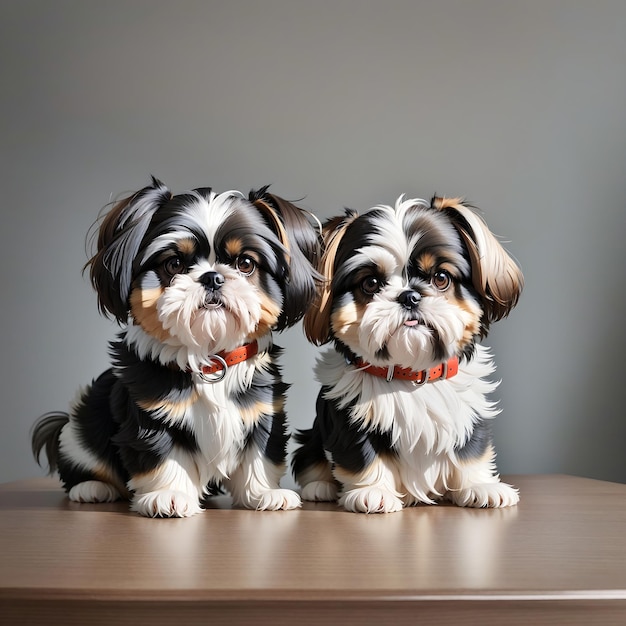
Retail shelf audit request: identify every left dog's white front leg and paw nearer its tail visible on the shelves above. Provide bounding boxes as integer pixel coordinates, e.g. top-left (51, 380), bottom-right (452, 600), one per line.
top-left (128, 448), bottom-right (202, 517)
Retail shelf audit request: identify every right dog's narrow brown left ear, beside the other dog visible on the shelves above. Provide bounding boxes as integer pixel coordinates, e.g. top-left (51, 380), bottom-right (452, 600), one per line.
top-left (303, 209), bottom-right (359, 346)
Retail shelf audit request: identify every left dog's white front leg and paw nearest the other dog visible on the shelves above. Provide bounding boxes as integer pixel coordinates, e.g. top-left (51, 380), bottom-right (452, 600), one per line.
top-left (225, 441), bottom-right (301, 511)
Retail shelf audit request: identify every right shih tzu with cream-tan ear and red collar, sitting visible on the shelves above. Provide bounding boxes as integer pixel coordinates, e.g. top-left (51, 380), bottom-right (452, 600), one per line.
top-left (292, 196), bottom-right (523, 513)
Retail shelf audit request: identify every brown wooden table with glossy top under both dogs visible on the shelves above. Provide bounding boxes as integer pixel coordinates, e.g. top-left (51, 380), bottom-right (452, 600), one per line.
top-left (0, 476), bottom-right (626, 626)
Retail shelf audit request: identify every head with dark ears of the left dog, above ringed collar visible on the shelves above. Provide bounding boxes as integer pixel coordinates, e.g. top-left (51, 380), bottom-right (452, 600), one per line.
top-left (90, 180), bottom-right (317, 366)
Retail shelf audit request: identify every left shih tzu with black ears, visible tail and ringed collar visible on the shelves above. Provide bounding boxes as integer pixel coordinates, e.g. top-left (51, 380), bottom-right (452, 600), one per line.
top-left (32, 179), bottom-right (319, 517)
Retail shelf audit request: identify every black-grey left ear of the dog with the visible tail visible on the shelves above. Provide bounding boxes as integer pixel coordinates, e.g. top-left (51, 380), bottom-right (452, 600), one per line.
top-left (85, 177), bottom-right (172, 324)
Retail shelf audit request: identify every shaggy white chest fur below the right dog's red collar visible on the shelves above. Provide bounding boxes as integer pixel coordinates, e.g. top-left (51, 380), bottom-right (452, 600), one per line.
top-left (316, 346), bottom-right (499, 501)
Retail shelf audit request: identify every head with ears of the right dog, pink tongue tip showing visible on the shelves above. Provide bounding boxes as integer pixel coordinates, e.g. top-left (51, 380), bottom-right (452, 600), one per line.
top-left (305, 198), bottom-right (523, 370)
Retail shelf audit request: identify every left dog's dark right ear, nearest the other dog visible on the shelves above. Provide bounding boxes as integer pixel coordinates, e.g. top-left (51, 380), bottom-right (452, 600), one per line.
top-left (248, 187), bottom-right (321, 331)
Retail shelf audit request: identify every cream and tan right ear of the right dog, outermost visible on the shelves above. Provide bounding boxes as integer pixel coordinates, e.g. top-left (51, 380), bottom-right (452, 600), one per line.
top-left (432, 197), bottom-right (524, 336)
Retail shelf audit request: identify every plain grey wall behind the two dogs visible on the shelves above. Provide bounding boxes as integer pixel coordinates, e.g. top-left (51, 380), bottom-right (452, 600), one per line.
top-left (0, 0), bottom-right (626, 484)
